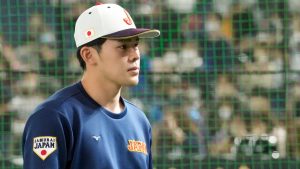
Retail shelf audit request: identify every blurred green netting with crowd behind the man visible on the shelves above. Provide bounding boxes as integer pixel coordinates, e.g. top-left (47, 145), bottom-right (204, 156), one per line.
top-left (0, 0), bottom-right (300, 169)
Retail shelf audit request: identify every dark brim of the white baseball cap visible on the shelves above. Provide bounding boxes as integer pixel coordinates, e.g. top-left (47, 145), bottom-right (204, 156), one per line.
top-left (102, 28), bottom-right (160, 39)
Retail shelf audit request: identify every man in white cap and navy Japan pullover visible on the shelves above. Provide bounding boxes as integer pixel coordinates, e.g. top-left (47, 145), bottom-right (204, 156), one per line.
top-left (23, 4), bottom-right (160, 169)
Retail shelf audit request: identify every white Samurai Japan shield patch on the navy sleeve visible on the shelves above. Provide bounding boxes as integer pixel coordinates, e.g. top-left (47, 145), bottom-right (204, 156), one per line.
top-left (33, 136), bottom-right (57, 160)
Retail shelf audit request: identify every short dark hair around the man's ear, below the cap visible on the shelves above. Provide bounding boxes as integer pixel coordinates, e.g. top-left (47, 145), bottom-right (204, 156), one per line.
top-left (77, 38), bottom-right (106, 70)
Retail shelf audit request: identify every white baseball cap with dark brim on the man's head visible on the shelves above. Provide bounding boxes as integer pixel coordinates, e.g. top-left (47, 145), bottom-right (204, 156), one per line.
top-left (74, 4), bottom-right (160, 47)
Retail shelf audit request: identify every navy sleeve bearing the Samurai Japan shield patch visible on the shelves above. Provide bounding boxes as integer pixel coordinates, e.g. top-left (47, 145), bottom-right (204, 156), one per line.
top-left (22, 108), bottom-right (72, 169)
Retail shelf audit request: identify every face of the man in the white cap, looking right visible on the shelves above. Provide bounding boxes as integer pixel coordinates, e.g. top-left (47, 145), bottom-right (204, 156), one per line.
top-left (93, 38), bottom-right (140, 86)
